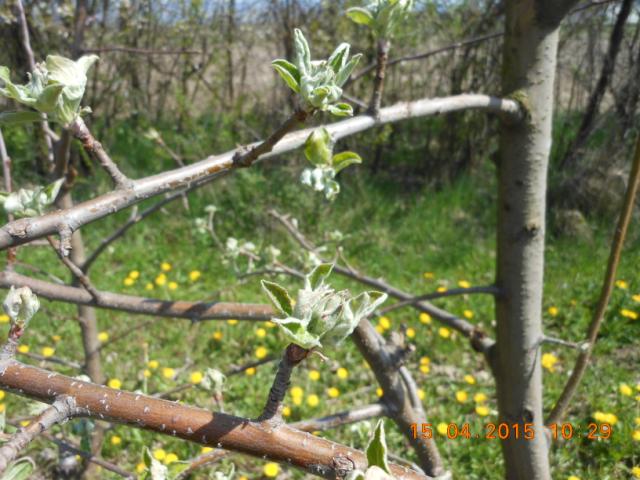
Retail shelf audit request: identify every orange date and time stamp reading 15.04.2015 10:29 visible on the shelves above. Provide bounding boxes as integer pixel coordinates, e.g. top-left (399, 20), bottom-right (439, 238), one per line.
top-left (411, 422), bottom-right (613, 440)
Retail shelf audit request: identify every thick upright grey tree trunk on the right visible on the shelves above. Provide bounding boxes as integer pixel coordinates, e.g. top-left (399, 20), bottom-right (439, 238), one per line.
top-left (492, 0), bottom-right (559, 480)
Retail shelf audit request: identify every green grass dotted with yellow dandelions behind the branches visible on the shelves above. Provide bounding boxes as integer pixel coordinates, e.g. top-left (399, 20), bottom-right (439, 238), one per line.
top-left (4, 125), bottom-right (640, 479)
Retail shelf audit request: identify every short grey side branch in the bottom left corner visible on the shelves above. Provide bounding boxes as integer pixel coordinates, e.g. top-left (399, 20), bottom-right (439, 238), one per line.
top-left (0, 397), bottom-right (76, 473)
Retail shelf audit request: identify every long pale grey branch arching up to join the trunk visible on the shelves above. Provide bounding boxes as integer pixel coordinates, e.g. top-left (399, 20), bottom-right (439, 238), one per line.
top-left (0, 94), bottom-right (520, 250)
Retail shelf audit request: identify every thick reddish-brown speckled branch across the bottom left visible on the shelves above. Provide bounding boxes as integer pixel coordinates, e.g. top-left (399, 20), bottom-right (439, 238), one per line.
top-left (0, 360), bottom-right (427, 480)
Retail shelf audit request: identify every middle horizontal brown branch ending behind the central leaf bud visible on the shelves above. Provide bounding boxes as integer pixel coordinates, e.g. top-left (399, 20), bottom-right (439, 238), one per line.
top-left (0, 271), bottom-right (275, 321)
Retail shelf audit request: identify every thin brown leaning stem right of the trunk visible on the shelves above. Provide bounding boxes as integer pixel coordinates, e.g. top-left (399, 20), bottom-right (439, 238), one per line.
top-left (546, 137), bottom-right (640, 425)
